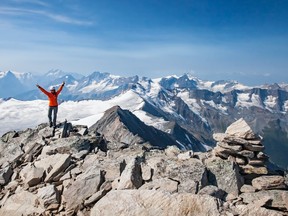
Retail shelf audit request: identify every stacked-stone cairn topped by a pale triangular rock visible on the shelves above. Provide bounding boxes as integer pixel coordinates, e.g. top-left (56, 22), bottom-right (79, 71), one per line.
top-left (213, 118), bottom-right (269, 178)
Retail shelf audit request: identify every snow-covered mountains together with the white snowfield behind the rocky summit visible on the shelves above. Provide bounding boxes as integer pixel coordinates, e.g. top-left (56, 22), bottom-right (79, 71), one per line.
top-left (0, 71), bottom-right (288, 166)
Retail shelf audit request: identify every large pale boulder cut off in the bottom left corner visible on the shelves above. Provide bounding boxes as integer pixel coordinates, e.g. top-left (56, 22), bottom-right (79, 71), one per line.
top-left (0, 189), bottom-right (45, 216)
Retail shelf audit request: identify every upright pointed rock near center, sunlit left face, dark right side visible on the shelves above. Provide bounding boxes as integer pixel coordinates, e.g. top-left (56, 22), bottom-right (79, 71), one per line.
top-left (117, 158), bottom-right (143, 190)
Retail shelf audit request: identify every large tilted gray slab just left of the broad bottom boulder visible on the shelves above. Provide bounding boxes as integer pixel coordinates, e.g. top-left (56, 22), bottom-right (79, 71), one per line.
top-left (62, 167), bottom-right (104, 210)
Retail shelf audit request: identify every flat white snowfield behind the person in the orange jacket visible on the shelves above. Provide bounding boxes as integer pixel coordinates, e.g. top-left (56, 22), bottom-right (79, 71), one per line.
top-left (0, 90), bottom-right (143, 135)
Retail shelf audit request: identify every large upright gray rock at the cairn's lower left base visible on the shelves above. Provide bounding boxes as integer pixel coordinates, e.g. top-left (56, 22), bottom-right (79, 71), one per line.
top-left (206, 158), bottom-right (244, 196)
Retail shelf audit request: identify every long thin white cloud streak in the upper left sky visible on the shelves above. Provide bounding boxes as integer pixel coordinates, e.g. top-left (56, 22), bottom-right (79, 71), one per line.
top-left (0, 7), bottom-right (94, 26)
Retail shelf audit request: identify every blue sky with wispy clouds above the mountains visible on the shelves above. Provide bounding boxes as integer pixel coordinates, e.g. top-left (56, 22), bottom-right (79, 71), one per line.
top-left (0, 0), bottom-right (288, 85)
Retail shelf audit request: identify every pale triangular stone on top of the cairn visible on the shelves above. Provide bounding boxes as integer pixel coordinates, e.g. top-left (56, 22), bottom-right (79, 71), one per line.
top-left (225, 118), bottom-right (259, 140)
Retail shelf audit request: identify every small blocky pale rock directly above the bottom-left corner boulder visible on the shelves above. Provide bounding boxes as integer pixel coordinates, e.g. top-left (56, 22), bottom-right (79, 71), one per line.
top-left (20, 163), bottom-right (44, 187)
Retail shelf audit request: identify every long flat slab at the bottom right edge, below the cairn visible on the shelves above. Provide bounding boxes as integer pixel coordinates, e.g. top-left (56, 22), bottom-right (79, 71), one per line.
top-left (240, 190), bottom-right (288, 210)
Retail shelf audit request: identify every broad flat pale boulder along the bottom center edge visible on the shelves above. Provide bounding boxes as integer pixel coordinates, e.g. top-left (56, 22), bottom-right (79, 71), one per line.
top-left (90, 190), bottom-right (220, 216)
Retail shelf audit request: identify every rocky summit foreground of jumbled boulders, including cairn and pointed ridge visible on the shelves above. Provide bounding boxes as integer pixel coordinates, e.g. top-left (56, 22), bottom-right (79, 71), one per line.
top-left (0, 107), bottom-right (288, 216)
